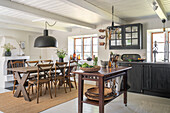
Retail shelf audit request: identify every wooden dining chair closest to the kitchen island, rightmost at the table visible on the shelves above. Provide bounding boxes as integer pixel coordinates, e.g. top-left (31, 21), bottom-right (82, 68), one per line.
top-left (66, 60), bottom-right (78, 91)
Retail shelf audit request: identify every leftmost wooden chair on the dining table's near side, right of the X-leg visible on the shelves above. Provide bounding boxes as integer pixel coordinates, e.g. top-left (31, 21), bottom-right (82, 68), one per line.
top-left (28, 64), bottom-right (53, 103)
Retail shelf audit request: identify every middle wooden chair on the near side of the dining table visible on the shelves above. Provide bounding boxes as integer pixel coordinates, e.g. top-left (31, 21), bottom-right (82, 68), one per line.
top-left (53, 62), bottom-right (68, 97)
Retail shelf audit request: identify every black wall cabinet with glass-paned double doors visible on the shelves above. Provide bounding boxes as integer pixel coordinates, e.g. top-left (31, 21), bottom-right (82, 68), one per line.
top-left (109, 24), bottom-right (143, 49)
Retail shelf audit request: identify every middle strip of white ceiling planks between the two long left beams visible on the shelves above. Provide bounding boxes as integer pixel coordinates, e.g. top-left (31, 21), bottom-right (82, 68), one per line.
top-left (12, 0), bottom-right (109, 24)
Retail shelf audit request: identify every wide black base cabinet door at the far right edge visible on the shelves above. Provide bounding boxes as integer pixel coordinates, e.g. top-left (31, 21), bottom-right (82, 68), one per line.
top-left (151, 65), bottom-right (170, 92)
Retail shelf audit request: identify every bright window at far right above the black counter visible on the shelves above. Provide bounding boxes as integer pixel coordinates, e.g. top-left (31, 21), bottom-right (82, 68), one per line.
top-left (152, 32), bottom-right (170, 62)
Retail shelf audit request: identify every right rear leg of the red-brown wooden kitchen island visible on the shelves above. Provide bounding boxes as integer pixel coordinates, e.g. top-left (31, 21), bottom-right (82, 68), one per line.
top-left (123, 72), bottom-right (127, 106)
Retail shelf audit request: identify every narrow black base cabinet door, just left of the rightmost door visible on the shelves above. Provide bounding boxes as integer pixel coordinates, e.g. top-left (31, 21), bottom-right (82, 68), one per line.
top-left (143, 65), bottom-right (151, 90)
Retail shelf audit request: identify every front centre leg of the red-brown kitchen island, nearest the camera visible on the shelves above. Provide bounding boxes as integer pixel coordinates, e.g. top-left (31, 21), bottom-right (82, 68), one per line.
top-left (99, 77), bottom-right (104, 113)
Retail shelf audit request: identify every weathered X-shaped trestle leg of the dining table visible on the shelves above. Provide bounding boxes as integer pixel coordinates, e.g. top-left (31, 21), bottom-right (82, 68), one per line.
top-left (14, 72), bottom-right (31, 101)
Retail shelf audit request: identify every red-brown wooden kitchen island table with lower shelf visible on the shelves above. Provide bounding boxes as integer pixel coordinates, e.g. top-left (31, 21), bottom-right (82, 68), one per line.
top-left (73, 67), bottom-right (131, 113)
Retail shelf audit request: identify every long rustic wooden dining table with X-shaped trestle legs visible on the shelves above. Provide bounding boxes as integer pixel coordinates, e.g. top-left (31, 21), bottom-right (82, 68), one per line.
top-left (7, 65), bottom-right (77, 101)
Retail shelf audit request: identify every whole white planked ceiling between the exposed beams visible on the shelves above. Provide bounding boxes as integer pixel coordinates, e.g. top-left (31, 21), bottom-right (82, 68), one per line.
top-left (0, 0), bottom-right (170, 32)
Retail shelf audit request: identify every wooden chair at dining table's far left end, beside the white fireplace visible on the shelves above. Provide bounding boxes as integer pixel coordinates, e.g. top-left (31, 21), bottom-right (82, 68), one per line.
top-left (10, 60), bottom-right (25, 94)
